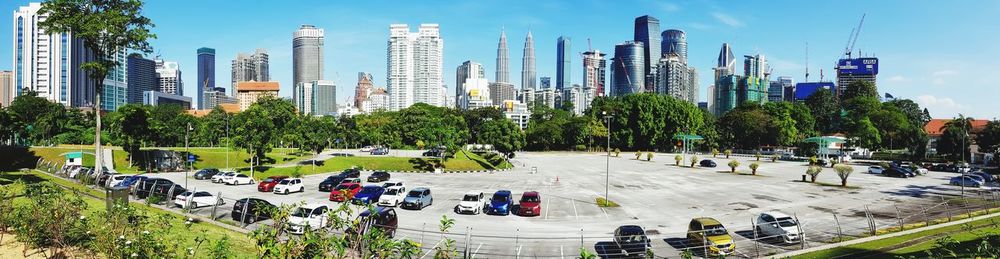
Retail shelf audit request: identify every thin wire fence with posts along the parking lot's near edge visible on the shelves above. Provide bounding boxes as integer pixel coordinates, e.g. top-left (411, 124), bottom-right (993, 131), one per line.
top-left (31, 161), bottom-right (1000, 258)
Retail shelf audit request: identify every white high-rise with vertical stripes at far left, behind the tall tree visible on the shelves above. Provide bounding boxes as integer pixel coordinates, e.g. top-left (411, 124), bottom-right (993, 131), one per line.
top-left (7, 3), bottom-right (97, 107)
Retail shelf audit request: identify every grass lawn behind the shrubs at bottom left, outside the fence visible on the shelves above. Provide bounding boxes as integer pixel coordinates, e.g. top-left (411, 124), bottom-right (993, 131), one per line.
top-left (0, 172), bottom-right (257, 258)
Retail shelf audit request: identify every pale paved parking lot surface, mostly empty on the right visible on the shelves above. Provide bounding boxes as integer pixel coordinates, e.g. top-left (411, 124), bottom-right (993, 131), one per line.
top-left (145, 152), bottom-right (992, 258)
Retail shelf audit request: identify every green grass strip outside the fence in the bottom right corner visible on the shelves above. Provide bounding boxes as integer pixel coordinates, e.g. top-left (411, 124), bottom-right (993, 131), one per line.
top-left (793, 213), bottom-right (1000, 258)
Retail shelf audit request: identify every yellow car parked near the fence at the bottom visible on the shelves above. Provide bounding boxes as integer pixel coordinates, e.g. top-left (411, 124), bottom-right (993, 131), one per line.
top-left (687, 217), bottom-right (736, 256)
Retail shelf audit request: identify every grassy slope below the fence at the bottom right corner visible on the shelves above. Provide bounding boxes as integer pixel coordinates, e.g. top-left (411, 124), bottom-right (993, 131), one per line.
top-left (793, 216), bottom-right (1000, 258)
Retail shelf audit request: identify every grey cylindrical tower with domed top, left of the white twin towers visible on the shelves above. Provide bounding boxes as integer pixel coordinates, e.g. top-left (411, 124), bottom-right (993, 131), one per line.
top-left (292, 24), bottom-right (324, 86)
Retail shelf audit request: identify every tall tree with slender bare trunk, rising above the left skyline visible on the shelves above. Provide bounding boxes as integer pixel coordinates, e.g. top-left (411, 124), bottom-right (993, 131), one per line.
top-left (38, 0), bottom-right (156, 176)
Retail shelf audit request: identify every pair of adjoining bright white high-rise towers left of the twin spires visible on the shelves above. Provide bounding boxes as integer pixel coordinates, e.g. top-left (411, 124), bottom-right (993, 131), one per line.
top-left (386, 24), bottom-right (445, 111)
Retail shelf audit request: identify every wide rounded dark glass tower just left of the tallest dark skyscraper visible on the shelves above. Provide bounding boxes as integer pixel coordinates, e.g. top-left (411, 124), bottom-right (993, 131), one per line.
top-left (611, 41), bottom-right (646, 96)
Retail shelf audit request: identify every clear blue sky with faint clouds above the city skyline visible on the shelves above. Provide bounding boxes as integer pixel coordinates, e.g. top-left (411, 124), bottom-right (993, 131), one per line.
top-left (0, 0), bottom-right (1000, 119)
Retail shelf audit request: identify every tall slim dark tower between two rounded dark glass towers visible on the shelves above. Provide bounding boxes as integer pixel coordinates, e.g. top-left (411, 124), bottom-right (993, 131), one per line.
top-left (633, 15), bottom-right (661, 92)
